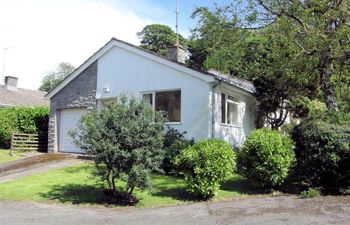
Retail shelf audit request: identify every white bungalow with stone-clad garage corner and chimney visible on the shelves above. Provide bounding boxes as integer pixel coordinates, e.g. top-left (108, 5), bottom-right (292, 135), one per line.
top-left (46, 38), bottom-right (256, 153)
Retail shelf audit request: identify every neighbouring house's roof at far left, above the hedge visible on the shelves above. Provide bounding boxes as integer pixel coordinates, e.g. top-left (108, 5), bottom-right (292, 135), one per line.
top-left (0, 85), bottom-right (49, 108)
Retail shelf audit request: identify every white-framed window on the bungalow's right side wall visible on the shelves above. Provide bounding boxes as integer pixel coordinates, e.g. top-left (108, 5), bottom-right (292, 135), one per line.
top-left (221, 94), bottom-right (239, 125)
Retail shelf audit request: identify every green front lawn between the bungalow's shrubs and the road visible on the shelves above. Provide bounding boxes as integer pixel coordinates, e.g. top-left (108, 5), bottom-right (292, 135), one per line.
top-left (0, 163), bottom-right (257, 207)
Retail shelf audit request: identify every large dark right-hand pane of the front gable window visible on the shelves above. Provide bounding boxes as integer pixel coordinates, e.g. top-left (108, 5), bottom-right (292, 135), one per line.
top-left (155, 90), bottom-right (181, 122)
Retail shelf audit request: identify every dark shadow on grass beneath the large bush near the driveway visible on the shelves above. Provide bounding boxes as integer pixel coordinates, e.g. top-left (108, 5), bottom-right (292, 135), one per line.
top-left (40, 184), bottom-right (138, 206)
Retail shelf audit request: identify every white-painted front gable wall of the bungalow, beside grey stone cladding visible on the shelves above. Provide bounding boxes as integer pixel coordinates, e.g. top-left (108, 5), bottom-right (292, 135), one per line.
top-left (96, 46), bottom-right (211, 140)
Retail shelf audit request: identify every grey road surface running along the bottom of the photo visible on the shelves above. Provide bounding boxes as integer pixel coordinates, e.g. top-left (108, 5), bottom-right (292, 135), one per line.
top-left (0, 196), bottom-right (350, 225)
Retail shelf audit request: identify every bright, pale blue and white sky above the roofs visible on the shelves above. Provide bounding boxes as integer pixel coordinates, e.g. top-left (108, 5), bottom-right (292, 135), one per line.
top-left (0, 0), bottom-right (229, 89)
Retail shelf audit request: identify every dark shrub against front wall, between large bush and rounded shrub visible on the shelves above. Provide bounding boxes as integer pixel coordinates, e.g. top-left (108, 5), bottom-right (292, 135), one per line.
top-left (161, 128), bottom-right (194, 174)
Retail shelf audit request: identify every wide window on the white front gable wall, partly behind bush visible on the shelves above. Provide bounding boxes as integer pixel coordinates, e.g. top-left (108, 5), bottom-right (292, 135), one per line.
top-left (143, 90), bottom-right (181, 122)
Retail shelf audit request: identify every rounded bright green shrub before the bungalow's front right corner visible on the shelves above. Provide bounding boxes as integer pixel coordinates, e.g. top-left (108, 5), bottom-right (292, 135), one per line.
top-left (176, 139), bottom-right (236, 199)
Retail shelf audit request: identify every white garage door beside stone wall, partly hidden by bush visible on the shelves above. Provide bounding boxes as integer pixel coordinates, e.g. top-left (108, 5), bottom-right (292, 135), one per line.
top-left (58, 109), bottom-right (87, 153)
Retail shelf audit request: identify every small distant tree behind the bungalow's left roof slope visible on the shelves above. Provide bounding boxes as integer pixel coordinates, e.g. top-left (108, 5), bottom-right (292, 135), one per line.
top-left (39, 62), bottom-right (75, 92)
